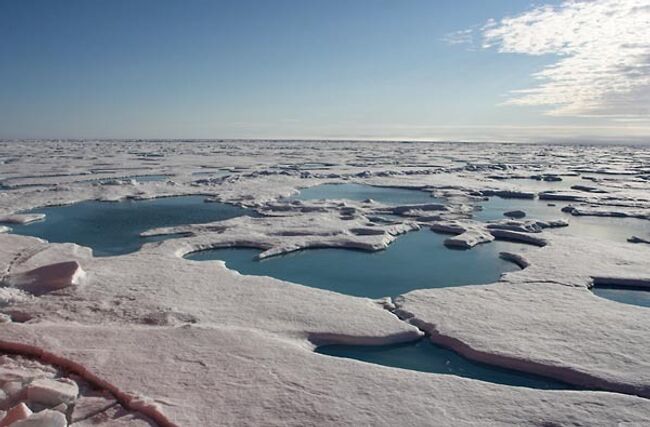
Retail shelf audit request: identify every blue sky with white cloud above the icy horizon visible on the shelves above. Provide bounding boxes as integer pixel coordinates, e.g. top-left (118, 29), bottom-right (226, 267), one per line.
top-left (0, 0), bottom-right (650, 143)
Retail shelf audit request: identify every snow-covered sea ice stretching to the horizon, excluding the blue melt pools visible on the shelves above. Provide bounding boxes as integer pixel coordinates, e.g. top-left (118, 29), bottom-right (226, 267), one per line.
top-left (0, 141), bottom-right (650, 426)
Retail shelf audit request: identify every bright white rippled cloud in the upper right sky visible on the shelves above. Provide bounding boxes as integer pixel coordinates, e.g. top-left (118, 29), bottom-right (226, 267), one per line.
top-left (482, 0), bottom-right (650, 118)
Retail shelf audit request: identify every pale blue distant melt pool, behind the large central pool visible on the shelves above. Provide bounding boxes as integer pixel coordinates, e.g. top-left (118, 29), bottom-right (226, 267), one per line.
top-left (292, 183), bottom-right (442, 205)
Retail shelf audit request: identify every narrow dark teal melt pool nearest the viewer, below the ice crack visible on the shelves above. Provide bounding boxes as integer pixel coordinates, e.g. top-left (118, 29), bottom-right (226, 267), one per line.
top-left (316, 338), bottom-right (573, 389)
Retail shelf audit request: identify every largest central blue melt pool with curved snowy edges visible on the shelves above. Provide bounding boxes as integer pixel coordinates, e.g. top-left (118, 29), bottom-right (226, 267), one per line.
top-left (188, 230), bottom-right (522, 298)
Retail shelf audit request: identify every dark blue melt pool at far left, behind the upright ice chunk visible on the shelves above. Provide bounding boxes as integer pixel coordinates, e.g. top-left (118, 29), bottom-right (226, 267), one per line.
top-left (5, 196), bottom-right (252, 256)
